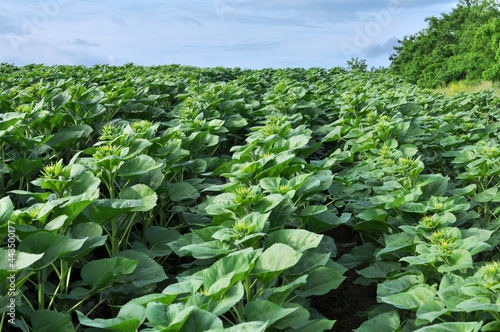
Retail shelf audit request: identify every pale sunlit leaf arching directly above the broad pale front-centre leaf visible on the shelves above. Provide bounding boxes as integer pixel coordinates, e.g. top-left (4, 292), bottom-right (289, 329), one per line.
top-left (263, 229), bottom-right (323, 253)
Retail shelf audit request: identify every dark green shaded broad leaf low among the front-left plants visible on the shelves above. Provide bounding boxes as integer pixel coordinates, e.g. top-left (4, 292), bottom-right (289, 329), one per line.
top-left (81, 257), bottom-right (138, 294)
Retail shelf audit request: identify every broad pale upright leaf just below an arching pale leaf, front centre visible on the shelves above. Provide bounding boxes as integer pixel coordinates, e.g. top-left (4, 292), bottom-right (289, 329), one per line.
top-left (252, 243), bottom-right (302, 284)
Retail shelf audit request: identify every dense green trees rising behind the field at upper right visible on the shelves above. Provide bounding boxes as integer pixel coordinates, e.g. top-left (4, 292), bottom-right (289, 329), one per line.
top-left (390, 0), bottom-right (500, 88)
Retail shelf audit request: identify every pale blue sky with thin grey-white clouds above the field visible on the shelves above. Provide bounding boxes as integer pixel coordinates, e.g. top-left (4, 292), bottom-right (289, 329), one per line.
top-left (0, 0), bottom-right (458, 69)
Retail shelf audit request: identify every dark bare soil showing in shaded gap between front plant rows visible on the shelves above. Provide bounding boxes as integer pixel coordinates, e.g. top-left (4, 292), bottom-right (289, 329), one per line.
top-left (311, 226), bottom-right (378, 332)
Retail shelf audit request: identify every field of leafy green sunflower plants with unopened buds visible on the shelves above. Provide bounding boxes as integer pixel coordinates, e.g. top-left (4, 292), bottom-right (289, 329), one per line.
top-left (0, 64), bottom-right (500, 332)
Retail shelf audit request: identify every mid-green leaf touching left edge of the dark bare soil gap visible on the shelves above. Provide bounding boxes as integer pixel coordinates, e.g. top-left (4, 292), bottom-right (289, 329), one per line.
top-left (300, 266), bottom-right (345, 296)
